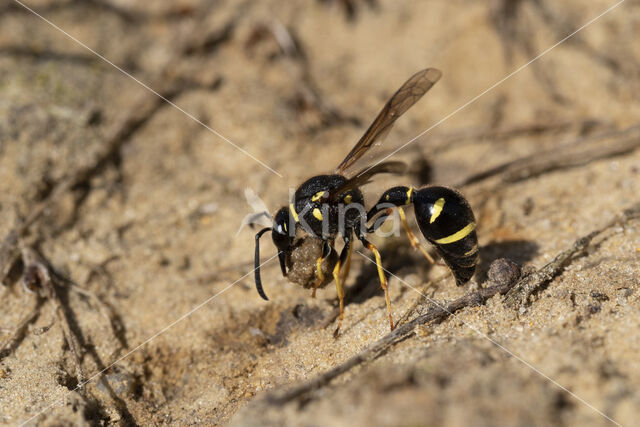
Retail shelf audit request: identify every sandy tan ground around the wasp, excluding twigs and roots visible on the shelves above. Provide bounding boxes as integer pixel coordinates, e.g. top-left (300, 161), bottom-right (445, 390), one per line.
top-left (0, 0), bottom-right (640, 426)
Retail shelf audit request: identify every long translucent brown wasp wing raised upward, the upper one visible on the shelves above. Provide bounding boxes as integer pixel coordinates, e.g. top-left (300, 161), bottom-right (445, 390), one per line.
top-left (336, 68), bottom-right (442, 174)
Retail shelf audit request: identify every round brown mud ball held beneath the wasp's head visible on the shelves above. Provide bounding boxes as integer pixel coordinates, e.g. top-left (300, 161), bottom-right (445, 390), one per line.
top-left (287, 234), bottom-right (338, 288)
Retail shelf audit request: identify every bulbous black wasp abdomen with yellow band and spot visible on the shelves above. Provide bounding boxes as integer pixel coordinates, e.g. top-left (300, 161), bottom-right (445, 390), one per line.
top-left (413, 187), bottom-right (478, 285)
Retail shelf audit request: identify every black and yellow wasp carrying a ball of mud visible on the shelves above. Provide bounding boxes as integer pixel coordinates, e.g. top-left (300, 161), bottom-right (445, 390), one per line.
top-left (255, 68), bottom-right (478, 336)
